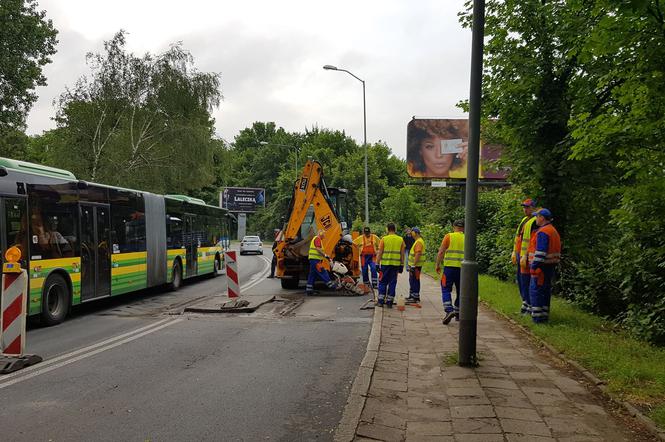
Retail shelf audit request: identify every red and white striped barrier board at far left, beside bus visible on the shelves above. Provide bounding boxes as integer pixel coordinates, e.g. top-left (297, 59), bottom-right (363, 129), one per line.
top-left (0, 270), bottom-right (28, 356)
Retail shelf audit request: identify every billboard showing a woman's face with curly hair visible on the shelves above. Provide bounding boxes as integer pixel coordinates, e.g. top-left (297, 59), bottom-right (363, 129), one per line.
top-left (406, 118), bottom-right (508, 180)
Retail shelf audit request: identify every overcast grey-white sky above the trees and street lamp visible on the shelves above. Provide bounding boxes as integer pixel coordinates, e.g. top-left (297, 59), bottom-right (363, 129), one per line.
top-left (28, 0), bottom-right (471, 158)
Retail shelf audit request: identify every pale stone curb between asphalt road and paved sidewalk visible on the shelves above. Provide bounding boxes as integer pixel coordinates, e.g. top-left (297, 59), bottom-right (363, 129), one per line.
top-left (333, 298), bottom-right (383, 442)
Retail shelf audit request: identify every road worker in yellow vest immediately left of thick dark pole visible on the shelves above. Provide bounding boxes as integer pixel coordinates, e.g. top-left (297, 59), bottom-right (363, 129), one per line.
top-left (436, 219), bottom-right (464, 325)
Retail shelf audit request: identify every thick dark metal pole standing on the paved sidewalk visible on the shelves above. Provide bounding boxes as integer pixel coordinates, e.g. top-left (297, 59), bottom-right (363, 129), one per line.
top-left (459, 0), bottom-right (485, 367)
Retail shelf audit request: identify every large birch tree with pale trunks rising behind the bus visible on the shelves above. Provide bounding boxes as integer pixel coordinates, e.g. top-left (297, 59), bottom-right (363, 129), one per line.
top-left (49, 31), bottom-right (221, 192)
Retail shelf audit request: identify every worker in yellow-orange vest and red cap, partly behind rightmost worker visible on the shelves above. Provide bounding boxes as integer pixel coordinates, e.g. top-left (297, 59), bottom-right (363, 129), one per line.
top-left (511, 198), bottom-right (537, 314)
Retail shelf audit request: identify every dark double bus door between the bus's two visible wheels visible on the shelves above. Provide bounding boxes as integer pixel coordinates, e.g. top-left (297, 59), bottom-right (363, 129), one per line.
top-left (80, 203), bottom-right (111, 301)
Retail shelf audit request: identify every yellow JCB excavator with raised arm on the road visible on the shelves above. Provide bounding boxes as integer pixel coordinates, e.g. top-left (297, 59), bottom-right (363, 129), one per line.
top-left (274, 160), bottom-right (366, 294)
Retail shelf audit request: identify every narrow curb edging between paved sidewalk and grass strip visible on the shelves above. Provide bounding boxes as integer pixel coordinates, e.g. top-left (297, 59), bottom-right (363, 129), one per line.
top-left (480, 301), bottom-right (665, 441)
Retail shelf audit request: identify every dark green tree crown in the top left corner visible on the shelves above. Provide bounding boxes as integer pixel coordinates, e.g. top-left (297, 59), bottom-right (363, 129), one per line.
top-left (0, 0), bottom-right (58, 129)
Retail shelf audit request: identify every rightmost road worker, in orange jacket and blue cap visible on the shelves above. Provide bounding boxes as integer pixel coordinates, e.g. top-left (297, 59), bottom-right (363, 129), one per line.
top-left (528, 209), bottom-right (561, 323)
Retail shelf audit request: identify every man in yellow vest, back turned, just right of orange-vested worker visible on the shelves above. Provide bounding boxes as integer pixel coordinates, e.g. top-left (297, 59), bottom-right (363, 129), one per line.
top-left (376, 223), bottom-right (404, 308)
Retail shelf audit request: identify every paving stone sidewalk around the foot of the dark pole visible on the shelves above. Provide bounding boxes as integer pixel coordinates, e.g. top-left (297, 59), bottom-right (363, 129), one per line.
top-left (355, 274), bottom-right (635, 442)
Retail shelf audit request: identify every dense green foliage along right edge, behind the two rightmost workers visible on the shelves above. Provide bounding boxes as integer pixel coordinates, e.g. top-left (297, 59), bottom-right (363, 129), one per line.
top-left (462, 0), bottom-right (665, 343)
